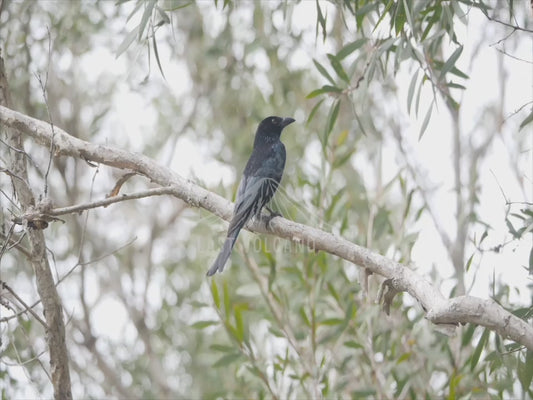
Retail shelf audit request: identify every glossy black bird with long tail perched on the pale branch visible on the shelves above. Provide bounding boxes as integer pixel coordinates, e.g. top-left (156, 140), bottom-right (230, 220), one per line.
top-left (207, 117), bottom-right (294, 276)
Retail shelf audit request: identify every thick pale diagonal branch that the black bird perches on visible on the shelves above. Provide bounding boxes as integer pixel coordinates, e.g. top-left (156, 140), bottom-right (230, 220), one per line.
top-left (0, 106), bottom-right (533, 350)
